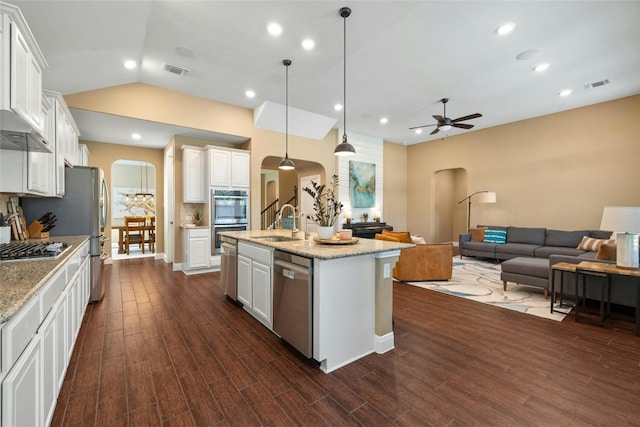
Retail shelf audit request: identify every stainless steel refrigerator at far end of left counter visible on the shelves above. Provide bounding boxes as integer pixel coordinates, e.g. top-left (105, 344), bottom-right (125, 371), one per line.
top-left (22, 166), bottom-right (109, 302)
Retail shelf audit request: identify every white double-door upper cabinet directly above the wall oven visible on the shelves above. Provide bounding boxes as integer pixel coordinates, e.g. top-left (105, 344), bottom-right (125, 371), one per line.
top-left (209, 146), bottom-right (250, 188)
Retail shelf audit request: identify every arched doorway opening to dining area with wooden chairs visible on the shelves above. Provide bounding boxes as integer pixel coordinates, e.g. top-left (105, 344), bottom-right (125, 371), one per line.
top-left (111, 159), bottom-right (156, 260)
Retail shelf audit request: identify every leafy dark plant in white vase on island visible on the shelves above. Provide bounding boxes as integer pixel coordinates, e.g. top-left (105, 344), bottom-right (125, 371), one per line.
top-left (302, 175), bottom-right (343, 240)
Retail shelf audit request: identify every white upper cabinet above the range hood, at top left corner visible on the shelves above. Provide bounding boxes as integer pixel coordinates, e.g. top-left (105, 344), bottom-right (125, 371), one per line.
top-left (0, 3), bottom-right (47, 134)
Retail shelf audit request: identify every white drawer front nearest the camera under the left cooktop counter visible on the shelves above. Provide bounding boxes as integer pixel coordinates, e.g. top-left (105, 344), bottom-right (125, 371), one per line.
top-left (2, 294), bottom-right (42, 370)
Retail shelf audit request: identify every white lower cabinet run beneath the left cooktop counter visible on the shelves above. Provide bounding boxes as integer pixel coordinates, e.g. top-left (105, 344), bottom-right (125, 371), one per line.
top-left (1, 242), bottom-right (91, 427)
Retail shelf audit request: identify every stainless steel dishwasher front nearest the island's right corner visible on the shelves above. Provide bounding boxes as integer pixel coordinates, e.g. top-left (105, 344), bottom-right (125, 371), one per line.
top-left (273, 251), bottom-right (313, 358)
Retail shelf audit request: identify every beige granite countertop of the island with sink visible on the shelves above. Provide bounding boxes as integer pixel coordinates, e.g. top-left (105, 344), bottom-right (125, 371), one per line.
top-left (220, 230), bottom-right (415, 259)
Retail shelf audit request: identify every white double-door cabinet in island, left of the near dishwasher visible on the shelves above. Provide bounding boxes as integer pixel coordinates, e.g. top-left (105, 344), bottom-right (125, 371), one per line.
top-left (237, 242), bottom-right (273, 329)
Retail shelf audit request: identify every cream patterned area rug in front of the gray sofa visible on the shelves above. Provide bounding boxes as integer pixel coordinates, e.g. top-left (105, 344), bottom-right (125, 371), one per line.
top-left (405, 258), bottom-right (571, 322)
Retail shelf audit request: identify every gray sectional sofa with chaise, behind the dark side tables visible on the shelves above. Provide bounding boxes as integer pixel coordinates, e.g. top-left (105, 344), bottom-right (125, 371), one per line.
top-left (458, 226), bottom-right (640, 307)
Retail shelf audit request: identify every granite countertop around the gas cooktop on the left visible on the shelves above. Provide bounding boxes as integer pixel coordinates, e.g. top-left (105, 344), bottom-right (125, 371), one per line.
top-left (0, 236), bottom-right (89, 324)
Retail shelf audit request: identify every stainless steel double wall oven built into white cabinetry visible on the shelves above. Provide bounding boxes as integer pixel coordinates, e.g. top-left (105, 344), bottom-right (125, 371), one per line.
top-left (211, 189), bottom-right (249, 255)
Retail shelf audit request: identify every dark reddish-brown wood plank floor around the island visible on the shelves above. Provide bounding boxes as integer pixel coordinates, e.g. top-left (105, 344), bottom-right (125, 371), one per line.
top-left (52, 258), bottom-right (640, 426)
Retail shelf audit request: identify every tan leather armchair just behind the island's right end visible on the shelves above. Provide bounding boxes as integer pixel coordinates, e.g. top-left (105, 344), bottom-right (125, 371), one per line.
top-left (375, 234), bottom-right (453, 282)
